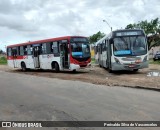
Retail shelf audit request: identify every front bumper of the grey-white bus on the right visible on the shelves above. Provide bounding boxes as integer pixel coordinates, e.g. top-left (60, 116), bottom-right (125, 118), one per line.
top-left (112, 61), bottom-right (148, 70)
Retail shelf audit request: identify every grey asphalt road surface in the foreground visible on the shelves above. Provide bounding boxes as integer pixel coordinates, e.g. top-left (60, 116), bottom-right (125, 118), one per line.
top-left (0, 71), bottom-right (160, 130)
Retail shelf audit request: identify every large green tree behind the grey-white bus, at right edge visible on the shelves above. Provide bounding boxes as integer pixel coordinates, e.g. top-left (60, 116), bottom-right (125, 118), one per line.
top-left (126, 18), bottom-right (160, 49)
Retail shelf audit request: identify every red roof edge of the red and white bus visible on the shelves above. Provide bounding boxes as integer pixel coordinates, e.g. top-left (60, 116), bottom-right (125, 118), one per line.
top-left (7, 36), bottom-right (86, 48)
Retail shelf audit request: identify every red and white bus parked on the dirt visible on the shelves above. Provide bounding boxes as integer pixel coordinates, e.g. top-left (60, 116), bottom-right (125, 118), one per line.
top-left (7, 36), bottom-right (91, 72)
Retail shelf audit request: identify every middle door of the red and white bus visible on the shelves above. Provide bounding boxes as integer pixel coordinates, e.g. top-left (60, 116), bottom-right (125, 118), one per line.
top-left (33, 46), bottom-right (40, 68)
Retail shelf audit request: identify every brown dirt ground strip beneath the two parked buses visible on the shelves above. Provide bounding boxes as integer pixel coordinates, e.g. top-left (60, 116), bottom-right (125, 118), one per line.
top-left (0, 64), bottom-right (160, 91)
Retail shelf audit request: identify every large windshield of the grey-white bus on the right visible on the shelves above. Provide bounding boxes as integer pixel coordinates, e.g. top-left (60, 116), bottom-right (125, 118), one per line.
top-left (113, 36), bottom-right (147, 56)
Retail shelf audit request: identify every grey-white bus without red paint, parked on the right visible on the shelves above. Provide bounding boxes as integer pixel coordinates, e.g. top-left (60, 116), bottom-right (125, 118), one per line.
top-left (95, 29), bottom-right (149, 72)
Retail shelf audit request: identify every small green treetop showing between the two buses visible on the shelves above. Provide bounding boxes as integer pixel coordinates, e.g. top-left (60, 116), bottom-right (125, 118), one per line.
top-left (89, 31), bottom-right (105, 44)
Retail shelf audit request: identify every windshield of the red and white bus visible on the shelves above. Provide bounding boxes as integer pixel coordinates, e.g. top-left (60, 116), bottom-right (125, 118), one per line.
top-left (71, 42), bottom-right (90, 58)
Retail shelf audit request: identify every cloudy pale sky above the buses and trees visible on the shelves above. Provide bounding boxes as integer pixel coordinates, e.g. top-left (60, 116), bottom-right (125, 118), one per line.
top-left (0, 0), bottom-right (160, 50)
